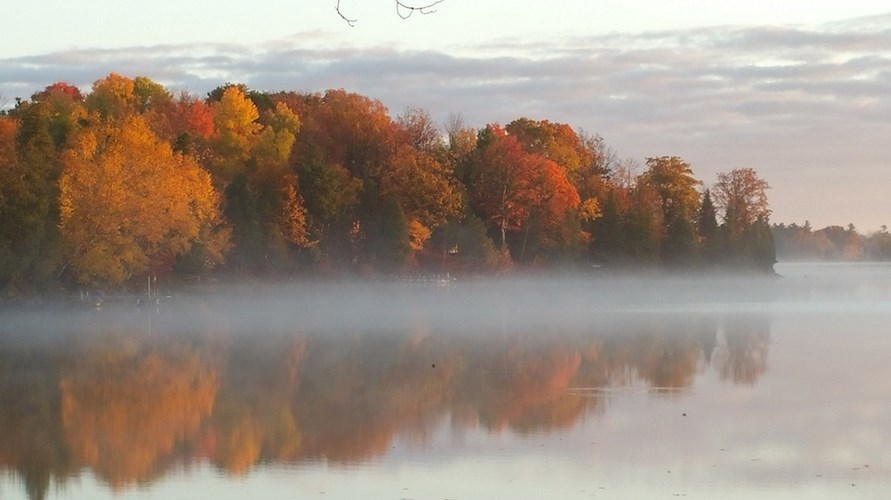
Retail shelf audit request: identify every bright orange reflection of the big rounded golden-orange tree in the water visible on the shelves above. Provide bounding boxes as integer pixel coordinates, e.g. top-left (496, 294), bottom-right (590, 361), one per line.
top-left (60, 349), bottom-right (217, 487)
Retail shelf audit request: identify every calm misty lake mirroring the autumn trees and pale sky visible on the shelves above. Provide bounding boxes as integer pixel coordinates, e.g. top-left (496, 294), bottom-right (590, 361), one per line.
top-left (0, 264), bottom-right (891, 499)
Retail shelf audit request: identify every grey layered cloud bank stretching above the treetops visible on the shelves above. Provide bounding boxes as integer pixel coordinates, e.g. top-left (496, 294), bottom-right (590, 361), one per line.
top-left (0, 16), bottom-right (891, 227)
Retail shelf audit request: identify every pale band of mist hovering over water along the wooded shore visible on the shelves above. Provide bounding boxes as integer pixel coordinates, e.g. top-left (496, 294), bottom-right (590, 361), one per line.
top-left (0, 264), bottom-right (891, 335)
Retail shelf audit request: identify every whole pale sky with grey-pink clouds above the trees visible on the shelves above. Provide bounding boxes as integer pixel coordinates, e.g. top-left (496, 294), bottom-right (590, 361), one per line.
top-left (0, 0), bottom-right (891, 232)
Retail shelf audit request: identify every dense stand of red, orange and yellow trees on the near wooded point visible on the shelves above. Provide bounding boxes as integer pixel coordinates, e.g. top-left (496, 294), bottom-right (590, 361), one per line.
top-left (0, 73), bottom-right (775, 296)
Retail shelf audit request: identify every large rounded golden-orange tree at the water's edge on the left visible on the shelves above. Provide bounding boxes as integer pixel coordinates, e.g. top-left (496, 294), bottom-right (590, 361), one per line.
top-left (60, 115), bottom-right (228, 285)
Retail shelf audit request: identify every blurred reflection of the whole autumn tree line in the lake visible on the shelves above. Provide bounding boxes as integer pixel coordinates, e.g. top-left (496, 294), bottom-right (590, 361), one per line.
top-left (0, 314), bottom-right (769, 498)
